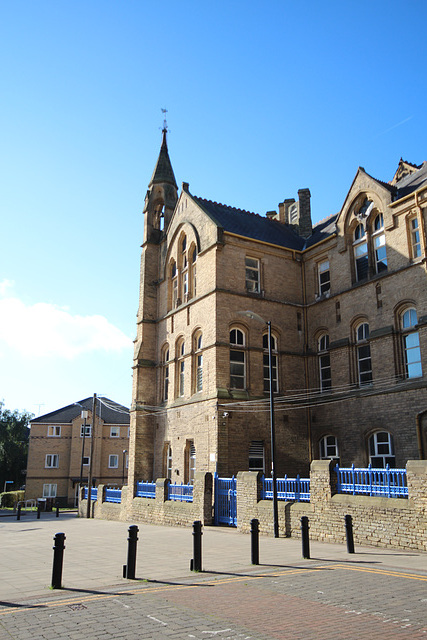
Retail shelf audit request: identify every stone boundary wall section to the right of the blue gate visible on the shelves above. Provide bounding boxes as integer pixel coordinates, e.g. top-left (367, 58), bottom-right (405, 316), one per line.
top-left (237, 460), bottom-right (427, 551)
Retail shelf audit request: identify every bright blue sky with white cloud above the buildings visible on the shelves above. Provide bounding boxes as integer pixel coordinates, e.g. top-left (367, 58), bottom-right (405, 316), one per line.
top-left (0, 0), bottom-right (427, 415)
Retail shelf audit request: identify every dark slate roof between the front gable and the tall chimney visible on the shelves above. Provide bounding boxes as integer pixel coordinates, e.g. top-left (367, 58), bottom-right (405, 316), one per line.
top-left (192, 196), bottom-right (305, 251)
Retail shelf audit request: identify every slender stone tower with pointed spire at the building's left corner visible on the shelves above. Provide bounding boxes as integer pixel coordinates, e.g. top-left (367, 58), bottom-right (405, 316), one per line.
top-left (128, 126), bottom-right (178, 484)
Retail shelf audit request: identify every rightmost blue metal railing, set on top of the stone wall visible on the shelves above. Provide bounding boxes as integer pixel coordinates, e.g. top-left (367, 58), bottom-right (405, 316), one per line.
top-left (335, 465), bottom-right (408, 498)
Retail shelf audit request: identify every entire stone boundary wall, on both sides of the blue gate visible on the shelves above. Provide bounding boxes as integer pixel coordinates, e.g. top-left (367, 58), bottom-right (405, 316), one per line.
top-left (79, 460), bottom-right (427, 551)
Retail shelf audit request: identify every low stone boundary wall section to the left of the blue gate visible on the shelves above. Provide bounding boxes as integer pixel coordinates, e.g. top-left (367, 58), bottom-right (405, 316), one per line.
top-left (79, 472), bottom-right (213, 526)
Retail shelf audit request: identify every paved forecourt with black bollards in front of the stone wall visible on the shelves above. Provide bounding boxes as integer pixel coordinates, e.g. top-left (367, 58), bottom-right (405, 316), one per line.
top-left (0, 514), bottom-right (427, 640)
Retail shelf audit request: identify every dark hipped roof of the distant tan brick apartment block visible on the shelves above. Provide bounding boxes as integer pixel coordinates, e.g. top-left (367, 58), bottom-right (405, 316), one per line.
top-left (31, 396), bottom-right (130, 424)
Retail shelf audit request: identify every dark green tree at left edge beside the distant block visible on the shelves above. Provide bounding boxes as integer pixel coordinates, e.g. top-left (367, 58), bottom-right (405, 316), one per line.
top-left (0, 402), bottom-right (34, 493)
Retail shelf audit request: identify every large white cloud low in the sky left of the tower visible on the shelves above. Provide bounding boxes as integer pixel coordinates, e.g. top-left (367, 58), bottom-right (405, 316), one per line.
top-left (0, 296), bottom-right (132, 359)
